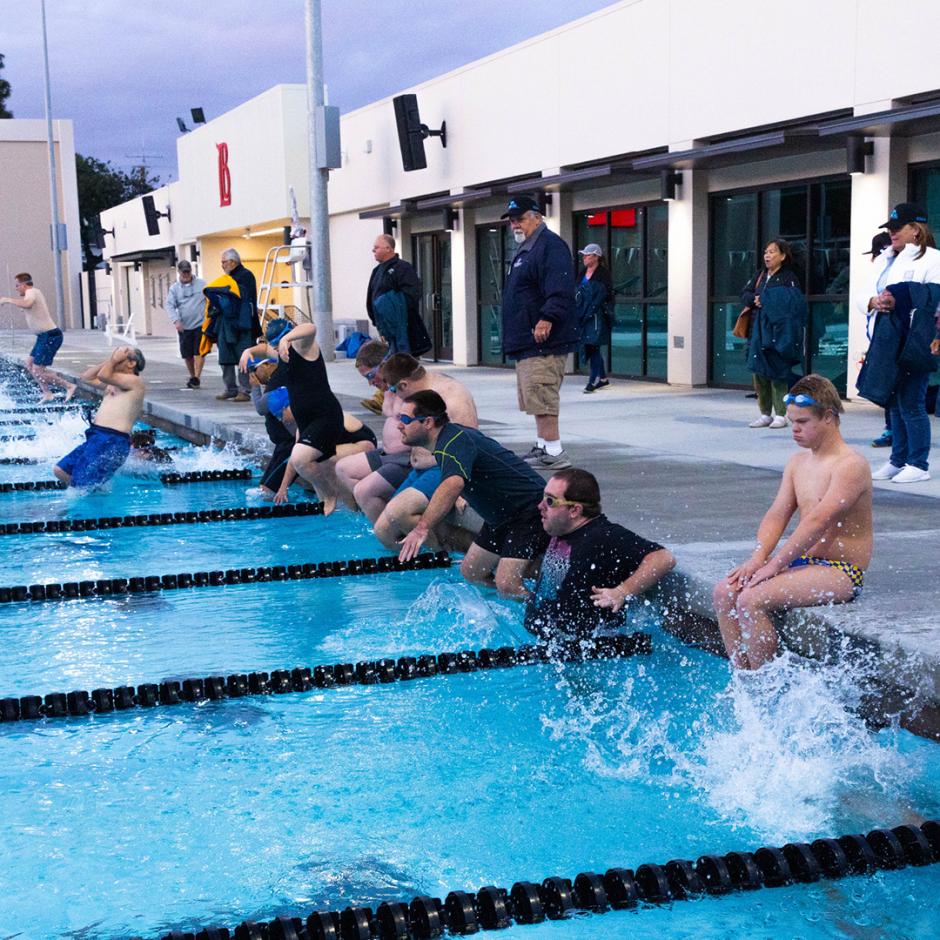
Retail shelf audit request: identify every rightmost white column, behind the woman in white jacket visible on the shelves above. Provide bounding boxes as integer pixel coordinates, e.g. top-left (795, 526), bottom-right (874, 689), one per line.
top-left (846, 137), bottom-right (907, 398)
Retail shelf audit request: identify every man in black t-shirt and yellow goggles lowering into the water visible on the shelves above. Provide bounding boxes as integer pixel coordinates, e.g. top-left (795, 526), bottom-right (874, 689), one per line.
top-left (525, 468), bottom-right (676, 637)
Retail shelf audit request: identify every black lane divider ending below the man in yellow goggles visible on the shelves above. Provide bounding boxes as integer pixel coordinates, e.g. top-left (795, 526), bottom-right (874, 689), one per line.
top-left (0, 633), bottom-right (653, 722)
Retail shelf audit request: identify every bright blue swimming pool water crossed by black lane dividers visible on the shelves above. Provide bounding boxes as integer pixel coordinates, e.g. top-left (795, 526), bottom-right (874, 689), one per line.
top-left (0, 362), bottom-right (940, 940)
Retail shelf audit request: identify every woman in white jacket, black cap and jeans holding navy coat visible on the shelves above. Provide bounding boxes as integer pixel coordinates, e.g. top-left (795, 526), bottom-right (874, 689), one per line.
top-left (858, 202), bottom-right (940, 483)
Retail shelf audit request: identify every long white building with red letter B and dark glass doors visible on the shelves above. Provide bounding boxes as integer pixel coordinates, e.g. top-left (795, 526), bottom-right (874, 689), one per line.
top-left (103, 0), bottom-right (940, 396)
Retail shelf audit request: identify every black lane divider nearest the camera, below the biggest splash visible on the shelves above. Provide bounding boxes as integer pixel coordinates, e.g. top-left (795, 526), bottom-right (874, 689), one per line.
top-left (162, 820), bottom-right (940, 940)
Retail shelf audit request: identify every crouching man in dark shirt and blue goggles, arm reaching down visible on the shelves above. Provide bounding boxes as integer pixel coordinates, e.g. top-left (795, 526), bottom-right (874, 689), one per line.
top-left (398, 390), bottom-right (548, 599)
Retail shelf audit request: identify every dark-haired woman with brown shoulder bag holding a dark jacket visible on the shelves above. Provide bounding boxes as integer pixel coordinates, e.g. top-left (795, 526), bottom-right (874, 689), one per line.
top-left (741, 238), bottom-right (806, 428)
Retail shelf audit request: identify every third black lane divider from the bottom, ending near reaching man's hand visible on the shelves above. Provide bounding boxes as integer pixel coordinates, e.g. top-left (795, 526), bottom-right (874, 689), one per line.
top-left (0, 552), bottom-right (451, 604)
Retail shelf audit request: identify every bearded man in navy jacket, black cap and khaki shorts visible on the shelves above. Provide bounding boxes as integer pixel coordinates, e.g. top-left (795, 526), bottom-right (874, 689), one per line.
top-left (502, 195), bottom-right (578, 470)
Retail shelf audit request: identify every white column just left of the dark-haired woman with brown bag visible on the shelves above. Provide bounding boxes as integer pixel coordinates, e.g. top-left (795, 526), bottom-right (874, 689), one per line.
top-left (666, 170), bottom-right (709, 385)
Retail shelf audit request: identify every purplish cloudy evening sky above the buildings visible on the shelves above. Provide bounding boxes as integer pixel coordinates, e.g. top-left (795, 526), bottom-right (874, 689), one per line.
top-left (0, 0), bottom-right (611, 181)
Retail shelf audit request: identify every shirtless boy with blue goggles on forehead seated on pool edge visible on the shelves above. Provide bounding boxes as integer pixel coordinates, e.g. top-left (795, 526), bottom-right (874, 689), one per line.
top-left (713, 375), bottom-right (872, 669)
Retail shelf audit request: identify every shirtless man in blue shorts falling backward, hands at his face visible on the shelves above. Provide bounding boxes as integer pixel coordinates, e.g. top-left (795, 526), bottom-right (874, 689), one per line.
top-left (52, 346), bottom-right (147, 486)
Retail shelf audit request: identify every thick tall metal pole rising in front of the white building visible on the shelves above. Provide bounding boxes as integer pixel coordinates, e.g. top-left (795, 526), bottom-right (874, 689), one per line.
top-left (304, 0), bottom-right (336, 362)
